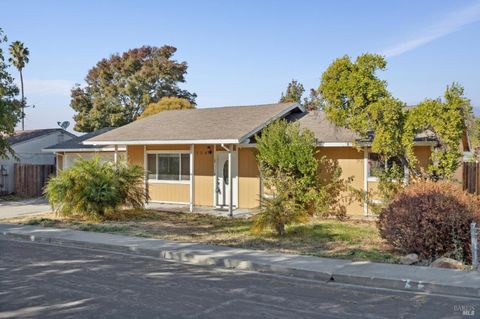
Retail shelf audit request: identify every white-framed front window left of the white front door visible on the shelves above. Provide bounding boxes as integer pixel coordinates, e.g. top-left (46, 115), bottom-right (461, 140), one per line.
top-left (147, 153), bottom-right (190, 181)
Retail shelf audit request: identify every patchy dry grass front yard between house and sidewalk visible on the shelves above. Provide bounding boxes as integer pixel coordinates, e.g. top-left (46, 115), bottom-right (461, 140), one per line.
top-left (2, 210), bottom-right (400, 262)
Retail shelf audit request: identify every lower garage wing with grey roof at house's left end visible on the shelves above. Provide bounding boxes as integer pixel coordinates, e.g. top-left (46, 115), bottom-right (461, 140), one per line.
top-left (43, 127), bottom-right (125, 173)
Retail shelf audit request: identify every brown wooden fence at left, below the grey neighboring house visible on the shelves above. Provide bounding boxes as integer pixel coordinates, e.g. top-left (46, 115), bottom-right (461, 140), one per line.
top-left (15, 164), bottom-right (55, 197)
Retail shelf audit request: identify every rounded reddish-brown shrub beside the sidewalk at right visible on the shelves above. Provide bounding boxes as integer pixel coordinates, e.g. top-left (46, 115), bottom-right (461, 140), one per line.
top-left (378, 181), bottom-right (480, 262)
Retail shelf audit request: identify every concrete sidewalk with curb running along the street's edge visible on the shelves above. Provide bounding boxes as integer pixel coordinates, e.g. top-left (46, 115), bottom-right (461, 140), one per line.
top-left (0, 224), bottom-right (480, 298)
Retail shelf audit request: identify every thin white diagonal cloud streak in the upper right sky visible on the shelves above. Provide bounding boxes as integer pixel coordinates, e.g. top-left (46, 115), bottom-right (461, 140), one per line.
top-left (382, 2), bottom-right (480, 57)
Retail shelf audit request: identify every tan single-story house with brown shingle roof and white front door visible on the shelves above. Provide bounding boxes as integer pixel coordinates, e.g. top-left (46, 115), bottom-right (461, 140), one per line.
top-left (84, 103), bottom-right (468, 215)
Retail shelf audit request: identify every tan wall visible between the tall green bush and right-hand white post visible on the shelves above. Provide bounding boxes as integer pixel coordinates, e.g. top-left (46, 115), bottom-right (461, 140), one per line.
top-left (317, 147), bottom-right (365, 216)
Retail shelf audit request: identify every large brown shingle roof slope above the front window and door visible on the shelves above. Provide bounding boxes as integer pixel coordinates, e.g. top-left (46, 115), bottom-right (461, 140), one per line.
top-left (86, 103), bottom-right (300, 144)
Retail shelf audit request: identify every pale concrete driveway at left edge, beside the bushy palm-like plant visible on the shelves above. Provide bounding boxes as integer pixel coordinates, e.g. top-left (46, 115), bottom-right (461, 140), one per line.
top-left (0, 197), bottom-right (52, 219)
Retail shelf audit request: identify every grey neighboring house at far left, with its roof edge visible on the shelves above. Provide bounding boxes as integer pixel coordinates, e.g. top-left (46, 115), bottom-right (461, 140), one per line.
top-left (0, 128), bottom-right (75, 194)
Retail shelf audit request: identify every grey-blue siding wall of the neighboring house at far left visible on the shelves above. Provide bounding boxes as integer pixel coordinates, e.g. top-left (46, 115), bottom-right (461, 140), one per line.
top-left (0, 131), bottom-right (72, 193)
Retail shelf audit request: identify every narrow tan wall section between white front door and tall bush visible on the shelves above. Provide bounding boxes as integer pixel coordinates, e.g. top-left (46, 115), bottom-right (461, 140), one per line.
top-left (238, 148), bottom-right (260, 208)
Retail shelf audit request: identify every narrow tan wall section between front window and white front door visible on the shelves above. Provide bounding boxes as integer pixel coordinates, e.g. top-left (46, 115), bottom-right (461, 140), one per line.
top-left (194, 145), bottom-right (215, 206)
